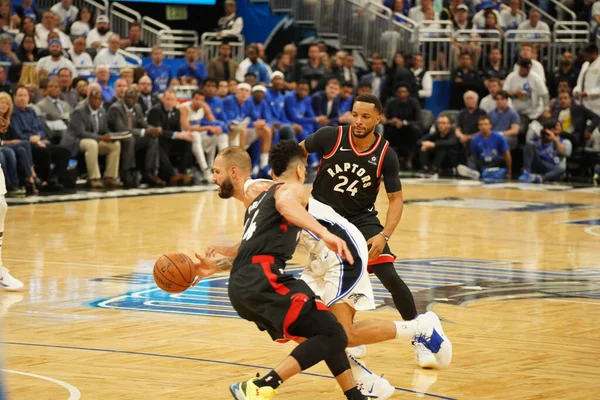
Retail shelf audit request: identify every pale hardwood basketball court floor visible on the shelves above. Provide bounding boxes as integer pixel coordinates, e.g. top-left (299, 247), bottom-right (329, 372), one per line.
top-left (0, 183), bottom-right (600, 400)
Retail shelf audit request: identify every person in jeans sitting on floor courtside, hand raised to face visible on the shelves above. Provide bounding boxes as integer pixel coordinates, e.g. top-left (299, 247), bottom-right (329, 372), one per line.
top-left (519, 119), bottom-right (571, 183)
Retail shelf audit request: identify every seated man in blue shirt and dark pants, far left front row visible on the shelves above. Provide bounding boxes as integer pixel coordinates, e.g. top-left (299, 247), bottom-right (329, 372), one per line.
top-left (9, 86), bottom-right (70, 191)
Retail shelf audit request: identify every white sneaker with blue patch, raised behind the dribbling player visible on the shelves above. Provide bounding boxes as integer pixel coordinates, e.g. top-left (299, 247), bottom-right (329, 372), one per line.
top-left (413, 311), bottom-right (452, 368)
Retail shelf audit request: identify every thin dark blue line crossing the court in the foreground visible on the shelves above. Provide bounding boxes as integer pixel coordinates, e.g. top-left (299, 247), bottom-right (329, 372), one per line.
top-left (2, 342), bottom-right (456, 400)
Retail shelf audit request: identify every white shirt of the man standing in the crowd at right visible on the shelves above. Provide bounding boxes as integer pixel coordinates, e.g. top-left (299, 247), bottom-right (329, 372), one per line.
top-left (502, 71), bottom-right (548, 119)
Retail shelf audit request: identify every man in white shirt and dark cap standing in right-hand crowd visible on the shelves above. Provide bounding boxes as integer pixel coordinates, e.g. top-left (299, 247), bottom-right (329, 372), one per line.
top-left (503, 58), bottom-right (549, 126)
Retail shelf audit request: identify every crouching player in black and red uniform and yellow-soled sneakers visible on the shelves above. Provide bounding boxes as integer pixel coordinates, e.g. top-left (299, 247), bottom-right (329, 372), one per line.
top-left (196, 142), bottom-right (368, 400)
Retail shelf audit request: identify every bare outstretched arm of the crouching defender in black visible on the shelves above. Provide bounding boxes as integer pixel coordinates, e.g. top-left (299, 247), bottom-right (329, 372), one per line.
top-left (275, 183), bottom-right (354, 264)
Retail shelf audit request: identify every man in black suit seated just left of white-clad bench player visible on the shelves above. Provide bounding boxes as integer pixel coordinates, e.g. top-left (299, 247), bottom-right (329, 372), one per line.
top-left (148, 89), bottom-right (194, 186)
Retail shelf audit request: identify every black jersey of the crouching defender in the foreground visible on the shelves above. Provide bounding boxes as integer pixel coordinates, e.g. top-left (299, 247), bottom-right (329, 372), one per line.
top-left (233, 184), bottom-right (300, 270)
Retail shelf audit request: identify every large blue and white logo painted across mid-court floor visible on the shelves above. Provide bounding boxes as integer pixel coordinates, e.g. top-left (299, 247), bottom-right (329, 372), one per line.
top-left (90, 258), bottom-right (600, 318)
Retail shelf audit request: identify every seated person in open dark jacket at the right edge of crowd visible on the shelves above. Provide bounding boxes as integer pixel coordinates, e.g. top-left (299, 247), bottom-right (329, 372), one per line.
top-left (552, 92), bottom-right (600, 148)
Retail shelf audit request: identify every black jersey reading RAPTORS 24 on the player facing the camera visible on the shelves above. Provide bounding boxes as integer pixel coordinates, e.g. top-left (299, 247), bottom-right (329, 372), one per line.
top-left (312, 126), bottom-right (389, 217)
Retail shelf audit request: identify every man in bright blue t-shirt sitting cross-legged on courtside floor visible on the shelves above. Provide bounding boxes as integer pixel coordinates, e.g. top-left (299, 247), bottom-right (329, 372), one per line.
top-left (458, 115), bottom-right (512, 180)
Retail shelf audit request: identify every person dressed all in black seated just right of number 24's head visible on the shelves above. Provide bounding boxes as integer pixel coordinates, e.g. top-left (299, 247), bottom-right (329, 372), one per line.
top-left (382, 83), bottom-right (423, 169)
